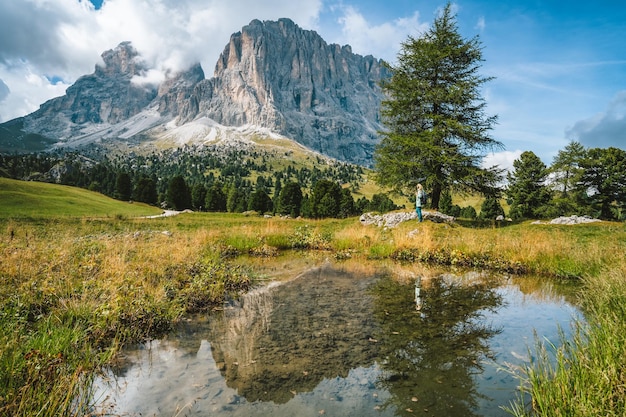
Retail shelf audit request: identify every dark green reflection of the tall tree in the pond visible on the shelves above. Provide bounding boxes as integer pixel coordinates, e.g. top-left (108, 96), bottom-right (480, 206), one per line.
top-left (372, 276), bottom-right (502, 416)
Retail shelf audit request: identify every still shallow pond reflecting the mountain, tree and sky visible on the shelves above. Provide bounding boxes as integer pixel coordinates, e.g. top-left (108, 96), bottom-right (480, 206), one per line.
top-left (95, 264), bottom-right (579, 417)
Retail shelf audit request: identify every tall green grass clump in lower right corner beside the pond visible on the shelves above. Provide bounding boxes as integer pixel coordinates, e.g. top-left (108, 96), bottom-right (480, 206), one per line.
top-left (508, 265), bottom-right (626, 417)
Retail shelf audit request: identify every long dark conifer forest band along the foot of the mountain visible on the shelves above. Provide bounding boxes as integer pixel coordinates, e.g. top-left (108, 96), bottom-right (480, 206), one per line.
top-left (0, 148), bottom-right (397, 218)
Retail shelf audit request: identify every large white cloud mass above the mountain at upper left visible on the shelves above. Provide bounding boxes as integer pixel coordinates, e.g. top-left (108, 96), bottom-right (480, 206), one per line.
top-left (0, 0), bottom-right (322, 122)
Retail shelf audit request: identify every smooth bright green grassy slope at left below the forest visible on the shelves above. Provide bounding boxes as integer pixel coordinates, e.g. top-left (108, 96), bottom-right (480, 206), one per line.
top-left (0, 178), bottom-right (161, 218)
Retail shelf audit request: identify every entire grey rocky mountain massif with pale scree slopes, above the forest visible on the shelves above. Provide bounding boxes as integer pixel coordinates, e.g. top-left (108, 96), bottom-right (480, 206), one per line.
top-left (0, 19), bottom-right (389, 165)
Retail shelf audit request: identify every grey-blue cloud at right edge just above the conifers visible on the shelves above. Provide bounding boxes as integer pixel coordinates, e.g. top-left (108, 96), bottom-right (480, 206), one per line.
top-left (567, 90), bottom-right (626, 149)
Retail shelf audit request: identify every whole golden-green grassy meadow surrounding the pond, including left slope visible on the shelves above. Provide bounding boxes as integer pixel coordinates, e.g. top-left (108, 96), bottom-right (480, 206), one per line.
top-left (0, 179), bottom-right (626, 416)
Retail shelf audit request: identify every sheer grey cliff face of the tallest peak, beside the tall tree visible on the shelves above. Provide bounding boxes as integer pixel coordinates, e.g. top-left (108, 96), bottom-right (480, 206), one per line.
top-left (200, 19), bottom-right (386, 163)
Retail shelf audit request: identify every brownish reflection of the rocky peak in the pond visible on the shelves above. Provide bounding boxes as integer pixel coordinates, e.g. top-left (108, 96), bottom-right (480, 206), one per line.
top-left (208, 267), bottom-right (379, 403)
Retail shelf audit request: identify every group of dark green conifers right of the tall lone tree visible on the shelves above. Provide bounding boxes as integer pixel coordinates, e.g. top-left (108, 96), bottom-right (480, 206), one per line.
top-left (439, 141), bottom-right (626, 220)
